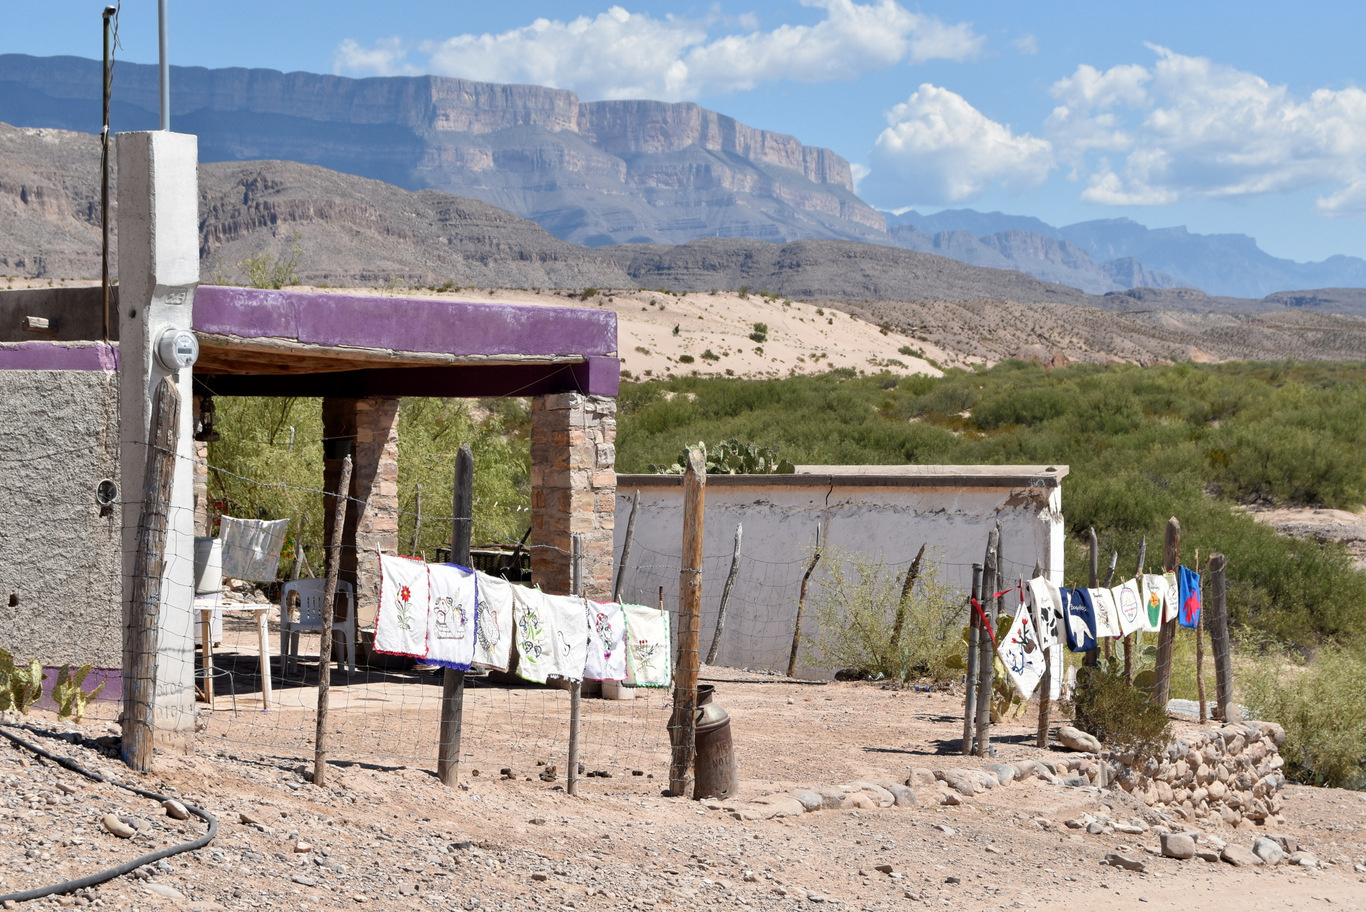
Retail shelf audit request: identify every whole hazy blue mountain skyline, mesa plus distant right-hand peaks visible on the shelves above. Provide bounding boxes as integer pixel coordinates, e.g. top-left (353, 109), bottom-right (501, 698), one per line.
top-left (8, 55), bottom-right (1366, 299)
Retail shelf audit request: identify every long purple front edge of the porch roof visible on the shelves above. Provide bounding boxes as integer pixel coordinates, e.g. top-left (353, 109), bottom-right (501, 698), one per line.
top-left (194, 285), bottom-right (616, 356)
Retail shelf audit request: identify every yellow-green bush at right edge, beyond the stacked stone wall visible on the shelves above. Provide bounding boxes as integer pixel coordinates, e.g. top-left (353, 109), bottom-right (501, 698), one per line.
top-left (1244, 646), bottom-right (1366, 789)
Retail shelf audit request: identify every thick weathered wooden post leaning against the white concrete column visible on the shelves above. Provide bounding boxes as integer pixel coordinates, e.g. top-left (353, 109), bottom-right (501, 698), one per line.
top-left (123, 377), bottom-right (180, 773)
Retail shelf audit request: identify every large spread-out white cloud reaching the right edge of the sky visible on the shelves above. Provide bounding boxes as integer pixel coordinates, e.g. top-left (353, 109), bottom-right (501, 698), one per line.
top-left (1045, 45), bottom-right (1366, 214)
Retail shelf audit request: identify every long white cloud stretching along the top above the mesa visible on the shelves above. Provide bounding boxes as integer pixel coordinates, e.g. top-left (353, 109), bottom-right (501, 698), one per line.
top-left (327, 0), bottom-right (985, 101)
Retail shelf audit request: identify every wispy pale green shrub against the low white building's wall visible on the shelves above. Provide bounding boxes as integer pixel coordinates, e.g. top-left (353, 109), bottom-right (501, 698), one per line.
top-left (806, 550), bottom-right (963, 681)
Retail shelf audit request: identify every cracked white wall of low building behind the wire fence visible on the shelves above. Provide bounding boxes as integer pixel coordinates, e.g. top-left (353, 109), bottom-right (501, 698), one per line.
top-left (615, 467), bottom-right (1065, 680)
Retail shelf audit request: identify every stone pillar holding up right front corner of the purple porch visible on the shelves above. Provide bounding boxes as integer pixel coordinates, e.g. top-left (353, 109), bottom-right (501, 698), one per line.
top-left (531, 393), bottom-right (616, 599)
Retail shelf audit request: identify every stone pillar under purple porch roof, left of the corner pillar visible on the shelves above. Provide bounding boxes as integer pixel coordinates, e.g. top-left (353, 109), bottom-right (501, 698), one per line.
top-left (322, 399), bottom-right (399, 641)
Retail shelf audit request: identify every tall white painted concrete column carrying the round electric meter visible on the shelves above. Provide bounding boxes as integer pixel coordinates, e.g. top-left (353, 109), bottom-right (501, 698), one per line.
top-left (116, 131), bottom-right (199, 750)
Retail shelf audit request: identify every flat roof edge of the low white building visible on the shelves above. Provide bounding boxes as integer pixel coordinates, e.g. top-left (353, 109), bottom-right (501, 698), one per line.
top-left (616, 466), bottom-right (1070, 490)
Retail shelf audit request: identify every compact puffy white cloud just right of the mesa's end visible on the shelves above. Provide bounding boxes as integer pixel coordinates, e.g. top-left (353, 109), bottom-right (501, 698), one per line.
top-left (867, 83), bottom-right (1053, 205)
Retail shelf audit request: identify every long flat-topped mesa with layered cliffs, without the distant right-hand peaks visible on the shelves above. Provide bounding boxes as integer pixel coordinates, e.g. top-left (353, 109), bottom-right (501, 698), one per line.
top-left (0, 55), bottom-right (887, 246)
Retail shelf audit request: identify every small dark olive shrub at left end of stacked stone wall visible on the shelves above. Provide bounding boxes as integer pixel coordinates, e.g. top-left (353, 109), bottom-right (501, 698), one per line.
top-left (1072, 658), bottom-right (1171, 756)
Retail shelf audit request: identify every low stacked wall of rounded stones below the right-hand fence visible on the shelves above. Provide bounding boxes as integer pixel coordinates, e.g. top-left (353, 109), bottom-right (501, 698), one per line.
top-left (1103, 722), bottom-right (1285, 826)
